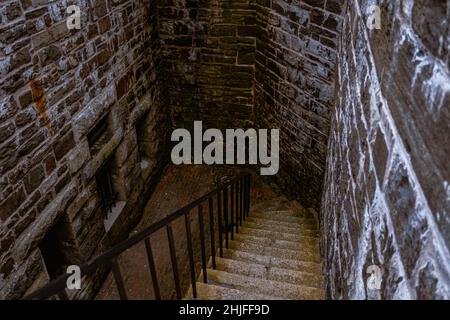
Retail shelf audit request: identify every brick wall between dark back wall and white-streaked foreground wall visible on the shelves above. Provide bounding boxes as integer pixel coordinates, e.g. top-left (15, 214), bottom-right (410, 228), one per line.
top-left (255, 0), bottom-right (342, 208)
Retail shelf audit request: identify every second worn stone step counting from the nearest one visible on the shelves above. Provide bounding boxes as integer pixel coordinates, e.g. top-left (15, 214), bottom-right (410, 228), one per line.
top-left (207, 269), bottom-right (324, 300)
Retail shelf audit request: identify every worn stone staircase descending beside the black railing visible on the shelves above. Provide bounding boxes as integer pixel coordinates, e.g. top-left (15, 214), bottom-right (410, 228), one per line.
top-left (187, 198), bottom-right (324, 300)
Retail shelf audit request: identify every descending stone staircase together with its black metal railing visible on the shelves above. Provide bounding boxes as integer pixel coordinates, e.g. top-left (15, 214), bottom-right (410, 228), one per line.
top-left (25, 172), bottom-right (324, 300)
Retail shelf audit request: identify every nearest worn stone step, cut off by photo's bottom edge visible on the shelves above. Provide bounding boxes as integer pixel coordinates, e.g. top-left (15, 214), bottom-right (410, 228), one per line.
top-left (187, 282), bottom-right (283, 300)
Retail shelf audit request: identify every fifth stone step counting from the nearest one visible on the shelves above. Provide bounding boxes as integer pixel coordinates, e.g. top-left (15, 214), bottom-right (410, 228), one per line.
top-left (229, 240), bottom-right (320, 262)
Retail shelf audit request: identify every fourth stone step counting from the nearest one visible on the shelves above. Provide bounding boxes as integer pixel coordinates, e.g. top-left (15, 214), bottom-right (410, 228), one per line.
top-left (223, 248), bottom-right (322, 276)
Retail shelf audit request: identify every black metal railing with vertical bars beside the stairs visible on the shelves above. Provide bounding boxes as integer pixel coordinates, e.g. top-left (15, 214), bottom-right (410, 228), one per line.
top-left (25, 173), bottom-right (251, 300)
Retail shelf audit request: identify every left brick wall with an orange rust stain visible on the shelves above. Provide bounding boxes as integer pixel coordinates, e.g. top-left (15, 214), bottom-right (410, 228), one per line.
top-left (0, 0), bottom-right (168, 299)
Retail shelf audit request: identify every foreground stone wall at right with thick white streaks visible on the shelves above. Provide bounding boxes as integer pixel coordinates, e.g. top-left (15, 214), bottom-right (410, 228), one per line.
top-left (321, 0), bottom-right (450, 299)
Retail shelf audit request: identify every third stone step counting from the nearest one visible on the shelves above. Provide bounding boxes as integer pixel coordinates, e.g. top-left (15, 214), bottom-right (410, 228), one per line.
top-left (216, 257), bottom-right (322, 289)
